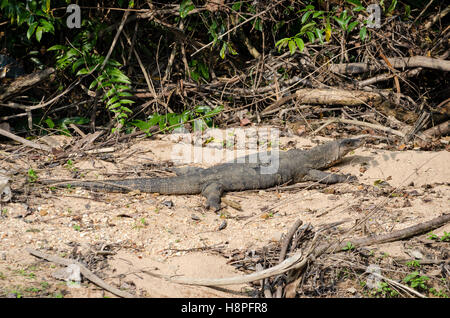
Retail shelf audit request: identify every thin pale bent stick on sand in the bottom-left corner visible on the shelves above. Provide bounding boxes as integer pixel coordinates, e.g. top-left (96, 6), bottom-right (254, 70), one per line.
top-left (26, 248), bottom-right (135, 298)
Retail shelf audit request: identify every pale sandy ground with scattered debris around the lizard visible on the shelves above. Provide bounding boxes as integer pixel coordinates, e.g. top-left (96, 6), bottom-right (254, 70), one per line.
top-left (0, 128), bottom-right (450, 297)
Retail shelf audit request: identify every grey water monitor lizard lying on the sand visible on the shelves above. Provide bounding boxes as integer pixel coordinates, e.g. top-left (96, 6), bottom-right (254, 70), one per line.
top-left (43, 139), bottom-right (362, 211)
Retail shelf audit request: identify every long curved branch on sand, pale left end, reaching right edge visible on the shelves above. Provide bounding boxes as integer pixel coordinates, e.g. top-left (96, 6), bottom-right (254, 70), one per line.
top-left (170, 214), bottom-right (450, 286)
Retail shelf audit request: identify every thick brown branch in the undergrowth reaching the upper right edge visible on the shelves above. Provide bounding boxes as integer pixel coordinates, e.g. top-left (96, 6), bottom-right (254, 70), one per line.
top-left (330, 56), bottom-right (450, 74)
